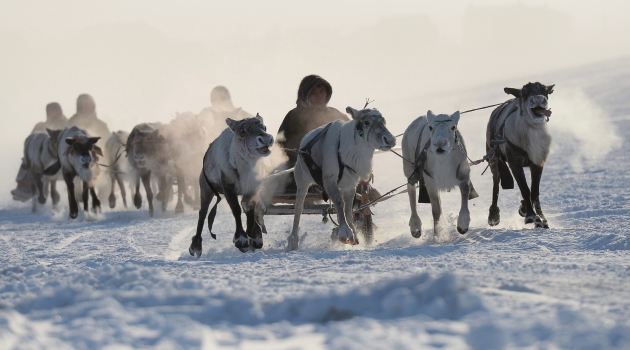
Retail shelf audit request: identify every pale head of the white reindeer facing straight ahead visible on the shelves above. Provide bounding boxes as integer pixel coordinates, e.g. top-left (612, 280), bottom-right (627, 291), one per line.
top-left (427, 111), bottom-right (459, 158)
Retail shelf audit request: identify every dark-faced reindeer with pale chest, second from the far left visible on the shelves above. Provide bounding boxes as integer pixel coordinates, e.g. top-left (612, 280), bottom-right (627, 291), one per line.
top-left (57, 126), bottom-right (103, 219)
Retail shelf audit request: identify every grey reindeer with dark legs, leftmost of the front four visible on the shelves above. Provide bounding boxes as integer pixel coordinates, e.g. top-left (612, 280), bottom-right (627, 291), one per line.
top-left (188, 114), bottom-right (274, 257)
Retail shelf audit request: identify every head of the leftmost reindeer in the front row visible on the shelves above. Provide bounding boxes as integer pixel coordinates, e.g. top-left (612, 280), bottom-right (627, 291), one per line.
top-left (225, 114), bottom-right (273, 158)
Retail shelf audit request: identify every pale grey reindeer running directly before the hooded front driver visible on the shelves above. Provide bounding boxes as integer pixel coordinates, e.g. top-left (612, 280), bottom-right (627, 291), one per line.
top-left (287, 107), bottom-right (396, 250)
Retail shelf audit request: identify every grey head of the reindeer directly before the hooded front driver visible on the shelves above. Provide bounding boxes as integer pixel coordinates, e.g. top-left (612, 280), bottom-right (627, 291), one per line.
top-left (346, 107), bottom-right (396, 151)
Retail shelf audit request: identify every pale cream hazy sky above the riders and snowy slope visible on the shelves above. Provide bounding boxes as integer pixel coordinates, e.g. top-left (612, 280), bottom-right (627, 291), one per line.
top-left (0, 0), bottom-right (630, 194)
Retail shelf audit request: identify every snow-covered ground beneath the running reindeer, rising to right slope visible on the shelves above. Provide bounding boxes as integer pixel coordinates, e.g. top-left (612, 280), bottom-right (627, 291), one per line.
top-left (0, 59), bottom-right (630, 349)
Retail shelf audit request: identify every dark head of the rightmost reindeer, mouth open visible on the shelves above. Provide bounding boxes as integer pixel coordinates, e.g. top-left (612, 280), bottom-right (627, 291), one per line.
top-left (503, 82), bottom-right (555, 124)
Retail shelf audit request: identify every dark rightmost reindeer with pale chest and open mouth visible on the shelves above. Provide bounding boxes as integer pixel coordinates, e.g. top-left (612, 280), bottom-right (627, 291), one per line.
top-left (486, 82), bottom-right (555, 228)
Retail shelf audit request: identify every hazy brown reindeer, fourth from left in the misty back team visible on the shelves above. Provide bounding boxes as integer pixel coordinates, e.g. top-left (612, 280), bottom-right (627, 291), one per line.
top-left (127, 123), bottom-right (174, 217)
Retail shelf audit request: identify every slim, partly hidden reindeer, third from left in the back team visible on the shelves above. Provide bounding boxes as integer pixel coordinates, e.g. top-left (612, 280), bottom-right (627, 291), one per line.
top-left (105, 130), bottom-right (135, 208)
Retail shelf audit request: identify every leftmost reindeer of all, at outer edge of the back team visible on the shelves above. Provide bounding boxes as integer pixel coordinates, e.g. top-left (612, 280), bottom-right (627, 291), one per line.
top-left (24, 129), bottom-right (63, 212)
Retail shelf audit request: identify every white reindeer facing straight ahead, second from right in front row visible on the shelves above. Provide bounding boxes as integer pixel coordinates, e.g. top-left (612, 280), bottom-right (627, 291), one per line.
top-left (402, 111), bottom-right (478, 238)
